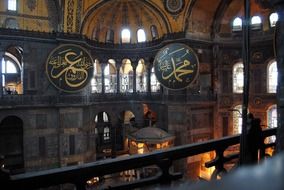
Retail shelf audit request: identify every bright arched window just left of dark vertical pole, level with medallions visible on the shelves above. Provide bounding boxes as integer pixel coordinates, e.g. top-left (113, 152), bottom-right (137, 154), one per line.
top-left (233, 63), bottom-right (244, 93)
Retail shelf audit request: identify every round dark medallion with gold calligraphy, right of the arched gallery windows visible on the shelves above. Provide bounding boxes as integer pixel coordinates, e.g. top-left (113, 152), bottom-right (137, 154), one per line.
top-left (154, 43), bottom-right (199, 90)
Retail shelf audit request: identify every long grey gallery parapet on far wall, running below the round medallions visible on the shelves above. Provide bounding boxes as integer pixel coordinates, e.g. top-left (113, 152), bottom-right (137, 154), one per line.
top-left (0, 93), bottom-right (215, 107)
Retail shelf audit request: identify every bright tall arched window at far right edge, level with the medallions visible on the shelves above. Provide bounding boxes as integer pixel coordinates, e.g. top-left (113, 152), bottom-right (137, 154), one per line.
top-left (267, 61), bottom-right (278, 93)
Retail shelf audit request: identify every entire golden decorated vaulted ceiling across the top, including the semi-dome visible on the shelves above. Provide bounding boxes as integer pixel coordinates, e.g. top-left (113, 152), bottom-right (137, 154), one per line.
top-left (0, 0), bottom-right (272, 43)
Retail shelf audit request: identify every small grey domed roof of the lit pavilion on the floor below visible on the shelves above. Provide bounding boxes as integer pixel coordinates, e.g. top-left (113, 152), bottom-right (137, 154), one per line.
top-left (129, 127), bottom-right (175, 143)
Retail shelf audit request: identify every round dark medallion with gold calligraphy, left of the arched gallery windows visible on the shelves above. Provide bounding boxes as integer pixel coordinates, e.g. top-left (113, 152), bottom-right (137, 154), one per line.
top-left (46, 44), bottom-right (94, 92)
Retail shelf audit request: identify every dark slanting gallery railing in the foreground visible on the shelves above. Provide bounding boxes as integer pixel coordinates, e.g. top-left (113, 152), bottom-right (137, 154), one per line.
top-left (1, 128), bottom-right (276, 190)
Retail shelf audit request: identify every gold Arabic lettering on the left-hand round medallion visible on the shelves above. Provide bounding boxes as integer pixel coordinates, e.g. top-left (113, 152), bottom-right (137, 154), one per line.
top-left (49, 49), bottom-right (92, 88)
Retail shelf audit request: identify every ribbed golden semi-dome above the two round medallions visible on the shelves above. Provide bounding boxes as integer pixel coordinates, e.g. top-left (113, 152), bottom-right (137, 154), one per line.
top-left (81, 0), bottom-right (171, 43)
